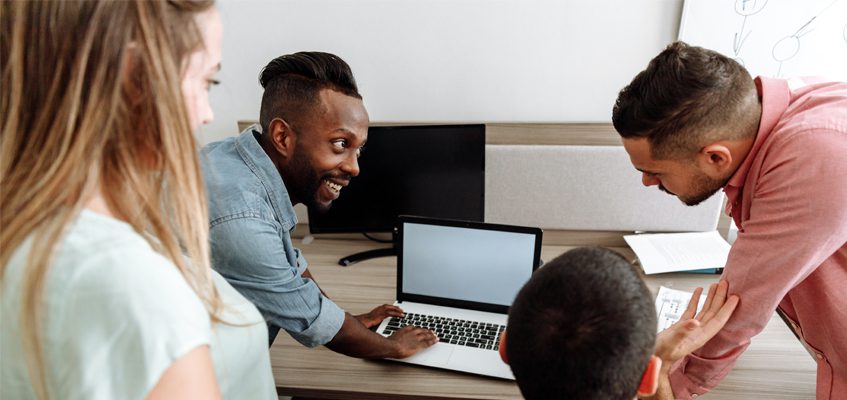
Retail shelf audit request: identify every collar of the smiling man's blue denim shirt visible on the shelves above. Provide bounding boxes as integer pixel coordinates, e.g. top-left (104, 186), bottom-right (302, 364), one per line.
top-left (235, 125), bottom-right (297, 229)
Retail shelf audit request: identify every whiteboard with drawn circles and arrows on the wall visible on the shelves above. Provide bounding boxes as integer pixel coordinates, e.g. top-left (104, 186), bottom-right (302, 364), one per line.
top-left (679, 0), bottom-right (847, 81)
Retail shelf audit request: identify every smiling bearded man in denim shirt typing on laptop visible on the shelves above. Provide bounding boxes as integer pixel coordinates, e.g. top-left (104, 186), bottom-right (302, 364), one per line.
top-left (200, 52), bottom-right (437, 358)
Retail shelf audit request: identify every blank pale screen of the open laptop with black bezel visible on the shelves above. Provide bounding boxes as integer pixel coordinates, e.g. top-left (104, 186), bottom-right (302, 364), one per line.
top-left (398, 217), bottom-right (541, 312)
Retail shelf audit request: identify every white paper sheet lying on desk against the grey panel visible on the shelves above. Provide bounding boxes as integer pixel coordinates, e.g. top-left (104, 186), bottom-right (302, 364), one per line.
top-left (624, 231), bottom-right (730, 274)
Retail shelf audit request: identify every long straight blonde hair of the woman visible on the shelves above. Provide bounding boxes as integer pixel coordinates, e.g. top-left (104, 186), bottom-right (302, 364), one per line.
top-left (0, 0), bottom-right (221, 398)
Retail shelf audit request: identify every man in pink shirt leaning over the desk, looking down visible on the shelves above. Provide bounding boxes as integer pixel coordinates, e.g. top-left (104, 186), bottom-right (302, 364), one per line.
top-left (612, 42), bottom-right (847, 399)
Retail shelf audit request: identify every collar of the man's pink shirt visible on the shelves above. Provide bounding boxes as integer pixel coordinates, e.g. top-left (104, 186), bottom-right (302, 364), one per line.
top-left (724, 76), bottom-right (791, 198)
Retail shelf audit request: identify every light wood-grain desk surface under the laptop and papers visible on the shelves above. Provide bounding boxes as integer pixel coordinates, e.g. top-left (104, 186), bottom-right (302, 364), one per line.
top-left (271, 238), bottom-right (815, 399)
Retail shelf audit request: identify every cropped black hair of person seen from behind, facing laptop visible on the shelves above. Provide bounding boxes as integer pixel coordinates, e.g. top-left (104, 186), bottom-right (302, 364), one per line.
top-left (506, 247), bottom-right (656, 400)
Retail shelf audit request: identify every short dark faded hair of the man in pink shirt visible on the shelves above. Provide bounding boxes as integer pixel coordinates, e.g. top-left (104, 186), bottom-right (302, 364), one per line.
top-left (612, 42), bottom-right (759, 159)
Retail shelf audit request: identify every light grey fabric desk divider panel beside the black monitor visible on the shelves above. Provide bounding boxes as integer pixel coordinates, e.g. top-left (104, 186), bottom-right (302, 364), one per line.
top-left (485, 145), bottom-right (723, 232)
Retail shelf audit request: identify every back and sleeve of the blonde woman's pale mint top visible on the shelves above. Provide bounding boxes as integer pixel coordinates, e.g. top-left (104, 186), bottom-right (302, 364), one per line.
top-left (4, 211), bottom-right (212, 398)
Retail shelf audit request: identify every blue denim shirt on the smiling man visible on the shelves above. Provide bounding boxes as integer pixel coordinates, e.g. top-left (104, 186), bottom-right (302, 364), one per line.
top-left (200, 126), bottom-right (345, 347)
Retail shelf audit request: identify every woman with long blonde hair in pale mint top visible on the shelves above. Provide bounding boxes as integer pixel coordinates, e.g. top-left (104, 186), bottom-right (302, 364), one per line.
top-left (0, 0), bottom-right (276, 399)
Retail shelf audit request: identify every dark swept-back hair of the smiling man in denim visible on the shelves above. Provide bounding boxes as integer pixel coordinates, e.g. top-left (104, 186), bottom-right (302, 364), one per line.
top-left (259, 51), bottom-right (362, 132)
